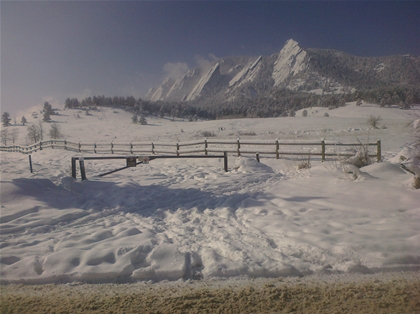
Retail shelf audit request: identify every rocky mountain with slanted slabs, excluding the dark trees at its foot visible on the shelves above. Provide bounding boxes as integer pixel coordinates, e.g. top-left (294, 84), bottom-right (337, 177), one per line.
top-left (146, 39), bottom-right (420, 103)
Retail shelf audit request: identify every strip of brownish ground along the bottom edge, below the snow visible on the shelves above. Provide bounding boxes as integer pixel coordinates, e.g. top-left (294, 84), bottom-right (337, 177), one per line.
top-left (0, 272), bottom-right (420, 314)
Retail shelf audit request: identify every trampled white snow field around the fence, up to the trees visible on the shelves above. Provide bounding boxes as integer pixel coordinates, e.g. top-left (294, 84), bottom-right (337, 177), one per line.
top-left (0, 104), bottom-right (420, 283)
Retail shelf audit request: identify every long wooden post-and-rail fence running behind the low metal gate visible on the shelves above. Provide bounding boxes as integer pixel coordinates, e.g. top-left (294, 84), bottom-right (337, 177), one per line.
top-left (0, 139), bottom-right (381, 161)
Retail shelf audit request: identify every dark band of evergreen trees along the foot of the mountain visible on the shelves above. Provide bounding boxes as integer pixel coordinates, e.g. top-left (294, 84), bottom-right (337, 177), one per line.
top-left (65, 84), bottom-right (420, 124)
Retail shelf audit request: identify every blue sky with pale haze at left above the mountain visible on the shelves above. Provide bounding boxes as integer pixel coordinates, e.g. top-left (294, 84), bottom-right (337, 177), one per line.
top-left (1, 1), bottom-right (420, 116)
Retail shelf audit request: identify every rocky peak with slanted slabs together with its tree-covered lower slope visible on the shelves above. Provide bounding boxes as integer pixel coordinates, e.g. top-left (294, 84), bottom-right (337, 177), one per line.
top-left (145, 39), bottom-right (420, 117)
